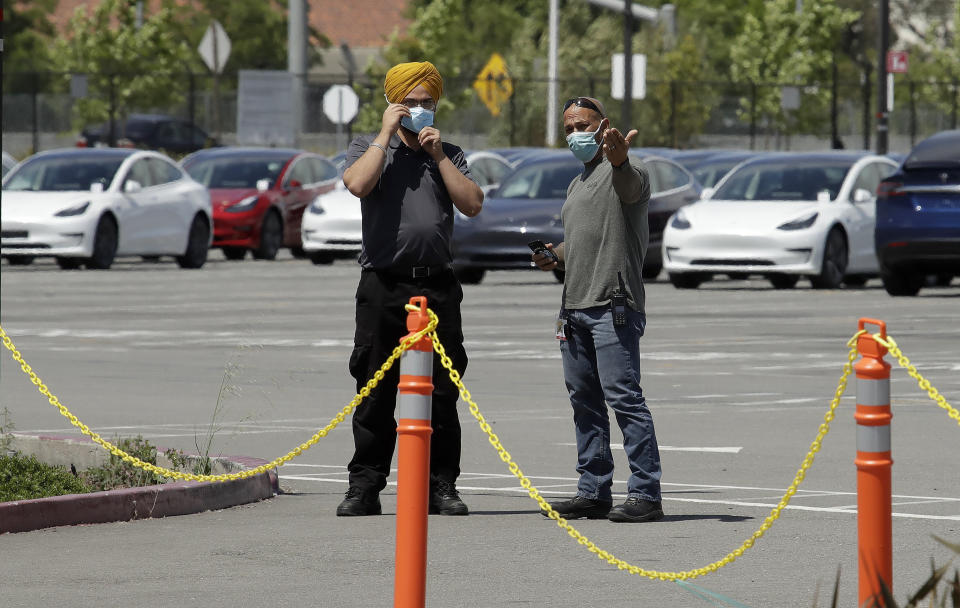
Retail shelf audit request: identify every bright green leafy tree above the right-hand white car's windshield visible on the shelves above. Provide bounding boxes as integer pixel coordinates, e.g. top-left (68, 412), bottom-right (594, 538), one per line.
top-left (731, 0), bottom-right (858, 138)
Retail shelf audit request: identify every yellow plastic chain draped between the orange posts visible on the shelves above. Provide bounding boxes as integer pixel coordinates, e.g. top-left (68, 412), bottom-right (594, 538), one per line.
top-left (0, 314), bottom-right (960, 581)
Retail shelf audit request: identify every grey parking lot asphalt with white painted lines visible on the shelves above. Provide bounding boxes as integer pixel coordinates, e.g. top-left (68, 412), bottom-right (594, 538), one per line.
top-left (0, 253), bottom-right (960, 607)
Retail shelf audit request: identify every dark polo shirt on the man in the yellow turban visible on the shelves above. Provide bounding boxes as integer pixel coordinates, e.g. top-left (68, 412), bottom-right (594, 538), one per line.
top-left (344, 134), bottom-right (473, 269)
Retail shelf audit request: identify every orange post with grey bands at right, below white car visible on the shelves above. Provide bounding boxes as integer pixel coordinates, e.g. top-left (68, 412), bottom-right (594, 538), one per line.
top-left (853, 319), bottom-right (893, 606)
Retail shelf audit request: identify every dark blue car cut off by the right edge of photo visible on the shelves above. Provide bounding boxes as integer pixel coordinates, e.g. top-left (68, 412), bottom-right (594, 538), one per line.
top-left (874, 130), bottom-right (960, 296)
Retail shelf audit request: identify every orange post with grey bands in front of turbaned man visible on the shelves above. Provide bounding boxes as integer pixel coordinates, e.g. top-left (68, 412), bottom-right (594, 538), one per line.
top-left (393, 296), bottom-right (433, 608)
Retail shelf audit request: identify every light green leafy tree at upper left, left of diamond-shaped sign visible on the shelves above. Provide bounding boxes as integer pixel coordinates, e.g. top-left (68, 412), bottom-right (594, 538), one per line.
top-left (54, 0), bottom-right (193, 135)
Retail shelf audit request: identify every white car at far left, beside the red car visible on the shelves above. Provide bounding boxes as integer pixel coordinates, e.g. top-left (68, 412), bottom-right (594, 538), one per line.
top-left (0, 148), bottom-right (213, 269)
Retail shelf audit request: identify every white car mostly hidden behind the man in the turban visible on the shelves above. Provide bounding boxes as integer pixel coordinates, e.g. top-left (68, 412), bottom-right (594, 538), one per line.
top-left (300, 150), bottom-right (513, 264)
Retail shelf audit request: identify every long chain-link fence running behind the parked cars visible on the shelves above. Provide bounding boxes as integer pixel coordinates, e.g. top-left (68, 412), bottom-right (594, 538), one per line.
top-left (3, 72), bottom-right (960, 157)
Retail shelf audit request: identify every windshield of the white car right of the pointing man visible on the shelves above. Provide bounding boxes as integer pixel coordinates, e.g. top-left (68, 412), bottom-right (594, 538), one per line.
top-left (711, 157), bottom-right (854, 201)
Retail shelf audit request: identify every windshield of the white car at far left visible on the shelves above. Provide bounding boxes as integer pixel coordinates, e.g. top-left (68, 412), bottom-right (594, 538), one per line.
top-left (3, 156), bottom-right (126, 192)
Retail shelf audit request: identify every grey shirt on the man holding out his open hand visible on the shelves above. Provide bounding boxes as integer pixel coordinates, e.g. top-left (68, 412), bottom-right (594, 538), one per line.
top-left (560, 155), bottom-right (650, 312)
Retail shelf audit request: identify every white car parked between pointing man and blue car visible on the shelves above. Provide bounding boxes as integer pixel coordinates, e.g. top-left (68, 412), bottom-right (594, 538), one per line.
top-left (663, 152), bottom-right (897, 289)
